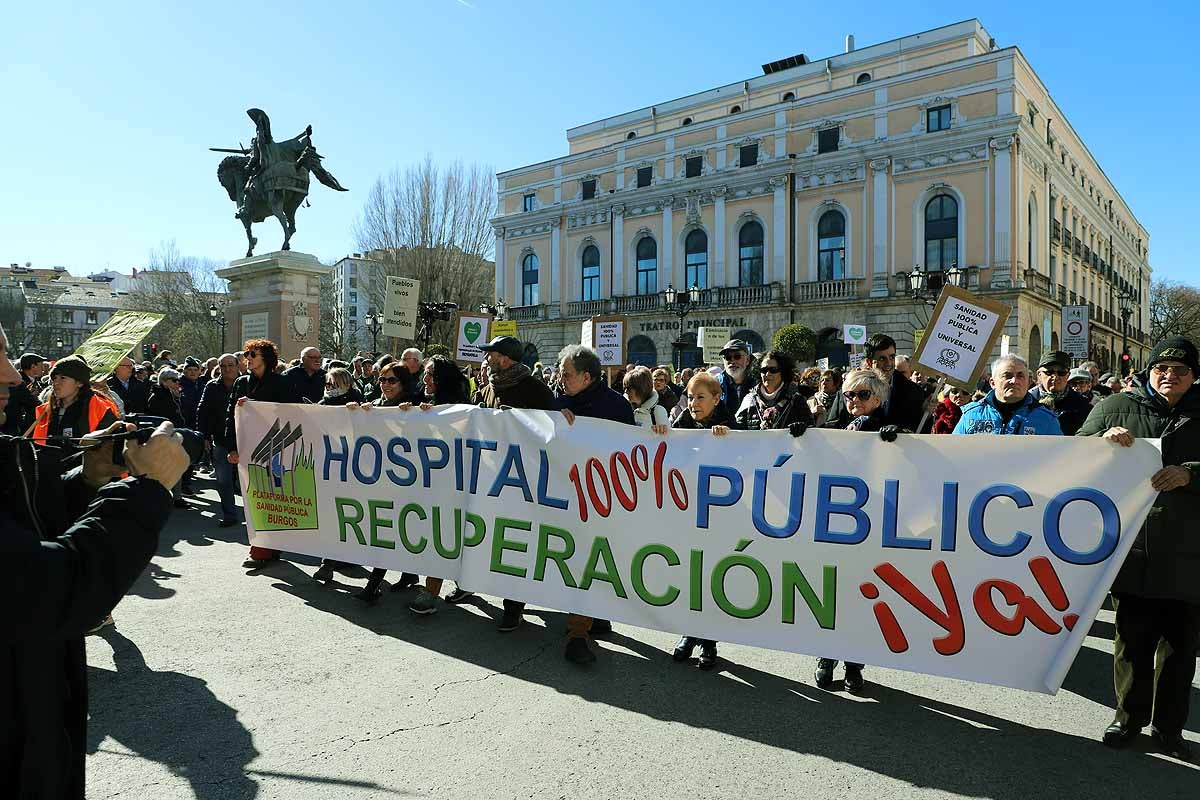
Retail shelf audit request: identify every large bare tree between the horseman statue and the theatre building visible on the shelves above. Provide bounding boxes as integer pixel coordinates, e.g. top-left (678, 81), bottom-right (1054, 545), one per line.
top-left (355, 156), bottom-right (496, 343)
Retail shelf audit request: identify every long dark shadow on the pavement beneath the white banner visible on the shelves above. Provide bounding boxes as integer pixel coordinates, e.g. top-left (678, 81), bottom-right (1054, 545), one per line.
top-left (256, 561), bottom-right (1200, 800)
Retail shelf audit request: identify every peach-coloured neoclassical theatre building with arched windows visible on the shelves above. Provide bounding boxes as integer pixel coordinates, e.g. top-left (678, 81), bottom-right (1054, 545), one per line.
top-left (493, 19), bottom-right (1151, 368)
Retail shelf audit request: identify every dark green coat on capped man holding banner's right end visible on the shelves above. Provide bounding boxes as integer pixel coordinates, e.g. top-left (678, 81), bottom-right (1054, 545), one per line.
top-left (1075, 384), bottom-right (1200, 603)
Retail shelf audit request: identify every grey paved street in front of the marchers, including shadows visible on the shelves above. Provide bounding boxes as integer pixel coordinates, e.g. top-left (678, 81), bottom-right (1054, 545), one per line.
top-left (88, 481), bottom-right (1200, 800)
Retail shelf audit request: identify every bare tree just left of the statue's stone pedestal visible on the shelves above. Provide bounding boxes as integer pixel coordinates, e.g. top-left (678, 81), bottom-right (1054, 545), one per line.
top-left (126, 240), bottom-right (229, 359)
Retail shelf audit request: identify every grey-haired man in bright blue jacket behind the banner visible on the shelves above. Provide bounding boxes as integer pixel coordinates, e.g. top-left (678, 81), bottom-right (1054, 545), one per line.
top-left (954, 353), bottom-right (1062, 437)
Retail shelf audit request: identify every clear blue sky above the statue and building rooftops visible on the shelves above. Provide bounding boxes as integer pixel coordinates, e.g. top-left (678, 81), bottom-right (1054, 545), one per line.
top-left (0, 0), bottom-right (1200, 283)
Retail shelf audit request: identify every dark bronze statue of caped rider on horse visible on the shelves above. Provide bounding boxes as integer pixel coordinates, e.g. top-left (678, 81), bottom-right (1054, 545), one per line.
top-left (210, 108), bottom-right (347, 258)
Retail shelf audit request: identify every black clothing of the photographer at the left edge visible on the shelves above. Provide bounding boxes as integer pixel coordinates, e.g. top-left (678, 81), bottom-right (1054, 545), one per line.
top-left (0, 465), bottom-right (170, 799)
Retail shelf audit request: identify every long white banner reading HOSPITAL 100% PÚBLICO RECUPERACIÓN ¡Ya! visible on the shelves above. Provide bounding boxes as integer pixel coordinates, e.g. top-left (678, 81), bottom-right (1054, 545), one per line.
top-left (236, 402), bottom-right (1162, 693)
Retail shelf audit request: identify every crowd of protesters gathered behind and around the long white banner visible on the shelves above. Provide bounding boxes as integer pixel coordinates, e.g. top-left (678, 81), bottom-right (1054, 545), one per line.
top-left (0, 335), bottom-right (1200, 757)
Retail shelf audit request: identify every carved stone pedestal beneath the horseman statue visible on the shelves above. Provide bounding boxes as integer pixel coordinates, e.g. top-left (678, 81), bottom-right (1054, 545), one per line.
top-left (217, 251), bottom-right (332, 361)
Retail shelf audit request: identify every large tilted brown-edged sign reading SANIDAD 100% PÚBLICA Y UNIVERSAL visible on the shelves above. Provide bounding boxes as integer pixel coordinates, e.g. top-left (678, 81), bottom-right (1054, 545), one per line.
top-left (913, 284), bottom-right (1012, 390)
